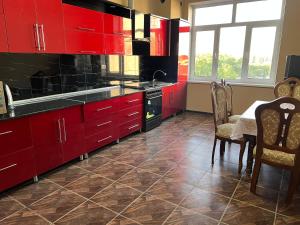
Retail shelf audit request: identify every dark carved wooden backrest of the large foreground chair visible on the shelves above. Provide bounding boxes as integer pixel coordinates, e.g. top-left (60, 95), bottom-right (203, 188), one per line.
top-left (255, 97), bottom-right (300, 157)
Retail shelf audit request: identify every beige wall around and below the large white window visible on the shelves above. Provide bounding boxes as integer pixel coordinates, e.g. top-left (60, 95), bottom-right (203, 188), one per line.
top-left (182, 0), bottom-right (300, 113)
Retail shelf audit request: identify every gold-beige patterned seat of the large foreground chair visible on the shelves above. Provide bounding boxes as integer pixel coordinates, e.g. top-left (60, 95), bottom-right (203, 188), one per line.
top-left (253, 147), bottom-right (295, 166)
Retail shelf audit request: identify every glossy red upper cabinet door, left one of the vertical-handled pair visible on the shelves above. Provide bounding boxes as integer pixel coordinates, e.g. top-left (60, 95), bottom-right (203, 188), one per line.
top-left (3, 0), bottom-right (37, 52)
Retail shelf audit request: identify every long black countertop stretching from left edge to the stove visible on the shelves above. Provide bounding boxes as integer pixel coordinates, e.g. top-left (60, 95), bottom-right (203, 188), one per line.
top-left (0, 88), bottom-right (143, 121)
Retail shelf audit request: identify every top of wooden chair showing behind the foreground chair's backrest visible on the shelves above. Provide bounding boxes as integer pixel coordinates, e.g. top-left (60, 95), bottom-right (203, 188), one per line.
top-left (274, 77), bottom-right (300, 100)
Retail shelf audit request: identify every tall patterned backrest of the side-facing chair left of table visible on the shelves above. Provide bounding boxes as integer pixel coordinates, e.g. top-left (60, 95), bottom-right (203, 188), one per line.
top-left (210, 82), bottom-right (228, 130)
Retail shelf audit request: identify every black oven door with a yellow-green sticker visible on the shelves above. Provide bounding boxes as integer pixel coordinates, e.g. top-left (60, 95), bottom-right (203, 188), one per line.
top-left (145, 95), bottom-right (162, 121)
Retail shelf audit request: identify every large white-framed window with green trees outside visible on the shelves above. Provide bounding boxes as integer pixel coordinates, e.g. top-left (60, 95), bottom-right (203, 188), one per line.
top-left (190, 0), bottom-right (285, 84)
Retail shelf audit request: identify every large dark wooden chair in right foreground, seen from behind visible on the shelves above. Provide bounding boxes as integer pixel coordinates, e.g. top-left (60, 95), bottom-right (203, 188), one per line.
top-left (251, 97), bottom-right (300, 204)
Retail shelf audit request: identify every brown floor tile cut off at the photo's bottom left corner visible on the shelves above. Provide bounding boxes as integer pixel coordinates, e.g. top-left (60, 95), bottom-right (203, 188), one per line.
top-left (0, 209), bottom-right (50, 225)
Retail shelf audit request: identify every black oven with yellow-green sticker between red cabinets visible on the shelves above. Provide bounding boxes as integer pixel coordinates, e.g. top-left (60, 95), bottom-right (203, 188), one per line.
top-left (143, 89), bottom-right (162, 131)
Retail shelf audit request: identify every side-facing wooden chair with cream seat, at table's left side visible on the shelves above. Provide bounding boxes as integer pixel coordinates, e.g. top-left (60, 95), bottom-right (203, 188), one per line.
top-left (211, 82), bottom-right (246, 173)
